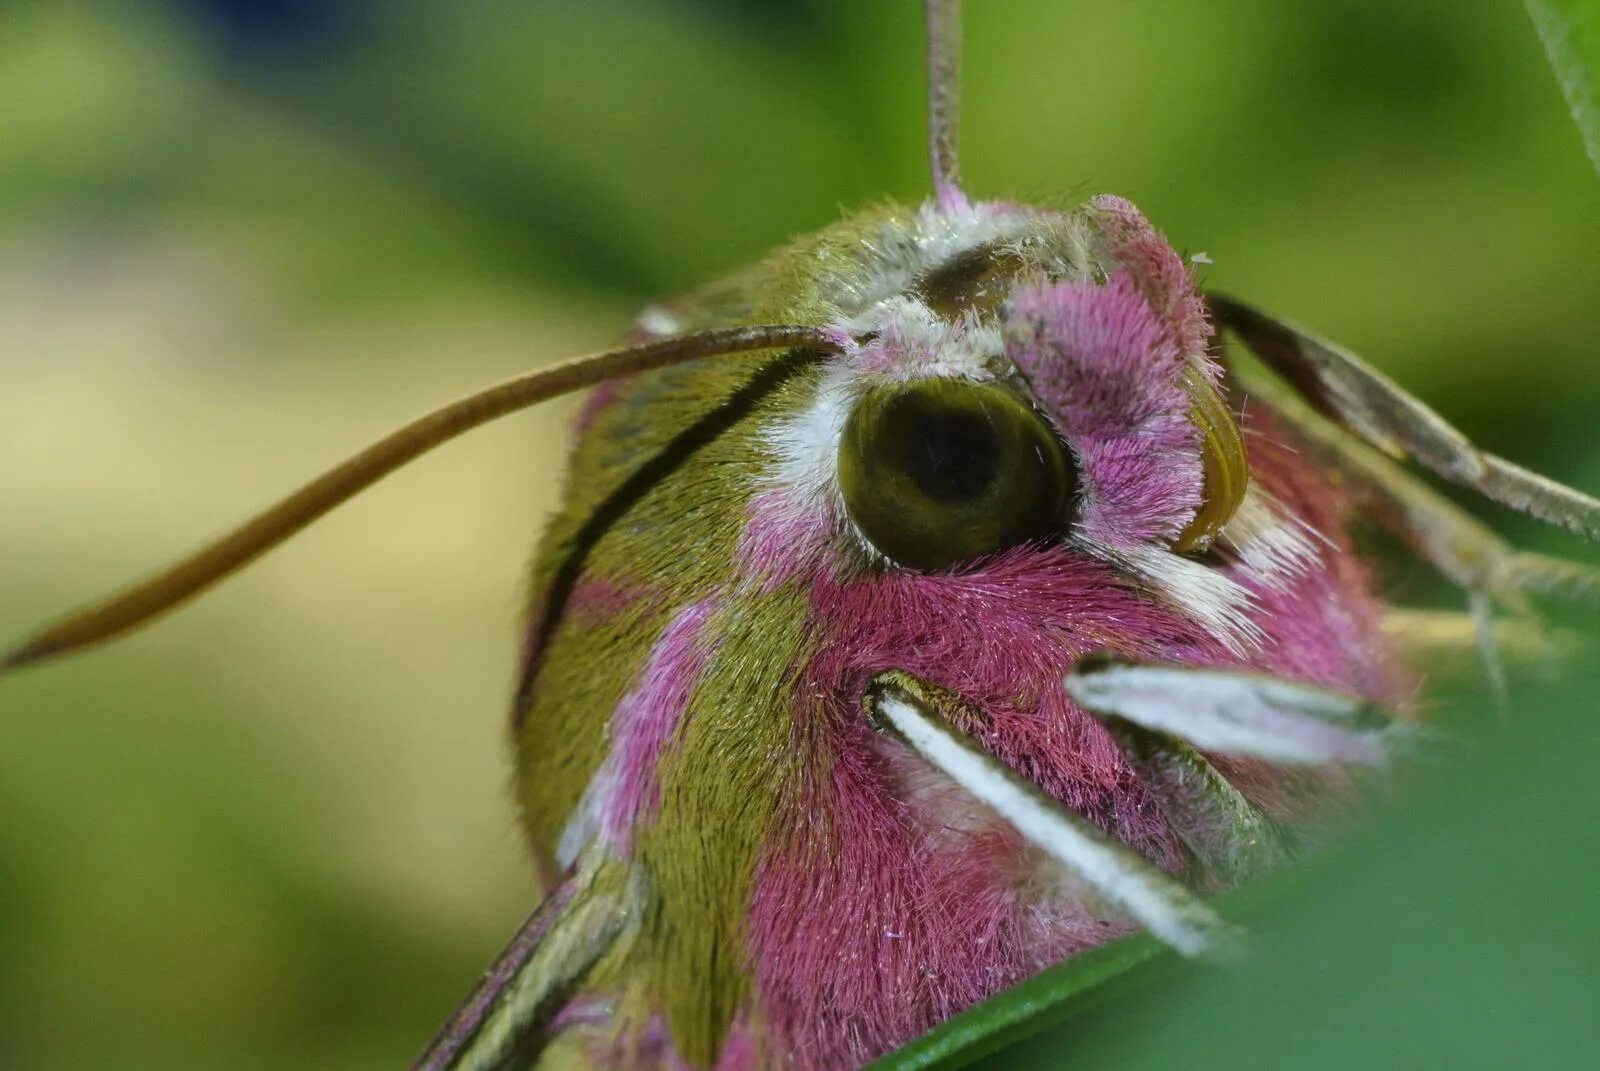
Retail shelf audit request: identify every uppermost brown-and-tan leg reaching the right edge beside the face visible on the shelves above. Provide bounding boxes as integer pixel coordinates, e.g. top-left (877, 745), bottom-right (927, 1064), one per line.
top-left (1206, 295), bottom-right (1600, 540)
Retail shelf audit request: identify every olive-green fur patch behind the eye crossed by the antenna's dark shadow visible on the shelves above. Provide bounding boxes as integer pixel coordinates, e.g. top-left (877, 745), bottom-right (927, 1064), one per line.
top-left (514, 354), bottom-right (819, 866)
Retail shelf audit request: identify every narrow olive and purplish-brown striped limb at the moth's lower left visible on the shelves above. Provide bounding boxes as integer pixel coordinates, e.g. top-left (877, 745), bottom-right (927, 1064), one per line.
top-left (411, 853), bottom-right (642, 1071)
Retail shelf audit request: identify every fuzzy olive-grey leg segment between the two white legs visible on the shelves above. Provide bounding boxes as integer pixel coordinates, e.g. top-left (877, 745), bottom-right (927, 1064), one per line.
top-left (1099, 716), bottom-right (1298, 885)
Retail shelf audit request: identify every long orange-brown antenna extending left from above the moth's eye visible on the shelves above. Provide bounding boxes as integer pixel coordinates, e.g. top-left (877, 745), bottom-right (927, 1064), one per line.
top-left (0, 323), bottom-right (842, 674)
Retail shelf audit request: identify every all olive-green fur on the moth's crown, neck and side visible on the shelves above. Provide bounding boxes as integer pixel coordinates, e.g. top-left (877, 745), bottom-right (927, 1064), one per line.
top-left (512, 205), bottom-right (1113, 1066)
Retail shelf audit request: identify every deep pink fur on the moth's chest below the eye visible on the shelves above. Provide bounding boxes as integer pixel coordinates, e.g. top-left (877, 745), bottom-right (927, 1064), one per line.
top-left (746, 405), bottom-right (1397, 1069)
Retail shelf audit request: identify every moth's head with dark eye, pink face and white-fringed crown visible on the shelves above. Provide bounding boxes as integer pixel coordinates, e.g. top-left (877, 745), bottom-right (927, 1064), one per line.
top-left (837, 199), bottom-right (1250, 570)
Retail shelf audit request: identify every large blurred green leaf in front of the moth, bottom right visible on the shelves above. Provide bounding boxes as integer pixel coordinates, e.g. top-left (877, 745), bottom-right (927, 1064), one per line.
top-left (870, 663), bottom-right (1600, 1071)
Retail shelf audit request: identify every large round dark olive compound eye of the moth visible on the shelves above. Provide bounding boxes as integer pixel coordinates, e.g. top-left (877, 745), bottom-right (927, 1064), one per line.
top-left (838, 378), bottom-right (1077, 570)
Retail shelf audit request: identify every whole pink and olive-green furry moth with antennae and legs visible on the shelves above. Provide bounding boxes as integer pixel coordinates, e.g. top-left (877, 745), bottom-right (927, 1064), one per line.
top-left (5, 0), bottom-right (1600, 1071)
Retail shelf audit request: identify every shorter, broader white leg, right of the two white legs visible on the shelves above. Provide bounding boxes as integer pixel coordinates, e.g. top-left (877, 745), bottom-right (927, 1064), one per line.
top-left (1062, 656), bottom-right (1422, 765)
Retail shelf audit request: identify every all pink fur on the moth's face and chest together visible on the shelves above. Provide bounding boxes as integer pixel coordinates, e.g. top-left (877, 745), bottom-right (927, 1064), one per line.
top-left (746, 199), bottom-right (1402, 1069)
